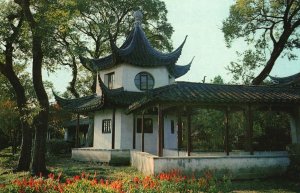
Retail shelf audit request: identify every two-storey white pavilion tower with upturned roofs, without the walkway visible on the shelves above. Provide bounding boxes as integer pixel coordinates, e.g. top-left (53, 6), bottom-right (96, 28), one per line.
top-left (56, 12), bottom-right (192, 154)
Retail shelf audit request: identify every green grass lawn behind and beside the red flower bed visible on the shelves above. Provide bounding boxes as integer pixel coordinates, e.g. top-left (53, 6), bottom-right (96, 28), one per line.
top-left (0, 149), bottom-right (300, 193)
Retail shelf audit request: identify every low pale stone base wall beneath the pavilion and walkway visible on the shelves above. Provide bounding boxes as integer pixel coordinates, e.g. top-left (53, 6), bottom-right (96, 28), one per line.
top-left (72, 148), bottom-right (290, 179)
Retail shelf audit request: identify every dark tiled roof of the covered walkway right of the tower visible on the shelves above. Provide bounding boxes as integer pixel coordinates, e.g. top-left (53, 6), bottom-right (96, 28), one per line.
top-left (128, 82), bottom-right (300, 112)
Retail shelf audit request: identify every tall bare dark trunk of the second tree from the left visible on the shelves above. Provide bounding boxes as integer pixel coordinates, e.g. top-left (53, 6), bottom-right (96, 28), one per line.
top-left (17, 0), bottom-right (49, 175)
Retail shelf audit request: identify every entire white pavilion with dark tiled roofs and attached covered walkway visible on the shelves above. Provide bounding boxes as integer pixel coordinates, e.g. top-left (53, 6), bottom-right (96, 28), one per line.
top-left (55, 11), bottom-right (300, 178)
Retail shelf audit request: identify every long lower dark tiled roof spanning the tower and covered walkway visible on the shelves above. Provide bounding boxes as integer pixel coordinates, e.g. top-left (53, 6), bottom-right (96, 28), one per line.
top-left (55, 82), bottom-right (300, 113)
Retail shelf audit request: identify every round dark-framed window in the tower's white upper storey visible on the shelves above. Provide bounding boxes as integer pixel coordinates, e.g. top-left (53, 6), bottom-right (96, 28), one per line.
top-left (134, 72), bottom-right (154, 90)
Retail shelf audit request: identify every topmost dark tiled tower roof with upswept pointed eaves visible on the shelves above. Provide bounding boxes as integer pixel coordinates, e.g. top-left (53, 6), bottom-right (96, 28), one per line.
top-left (80, 11), bottom-right (191, 78)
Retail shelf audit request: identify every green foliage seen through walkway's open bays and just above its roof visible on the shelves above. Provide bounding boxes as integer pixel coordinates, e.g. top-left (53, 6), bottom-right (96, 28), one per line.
top-left (190, 76), bottom-right (291, 151)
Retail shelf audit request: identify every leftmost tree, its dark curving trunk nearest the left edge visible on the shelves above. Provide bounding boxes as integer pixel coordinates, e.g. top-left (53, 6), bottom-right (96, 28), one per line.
top-left (0, 2), bottom-right (32, 170)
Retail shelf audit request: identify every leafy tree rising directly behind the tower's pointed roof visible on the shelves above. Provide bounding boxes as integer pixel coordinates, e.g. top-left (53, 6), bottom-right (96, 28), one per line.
top-left (55, 0), bottom-right (173, 98)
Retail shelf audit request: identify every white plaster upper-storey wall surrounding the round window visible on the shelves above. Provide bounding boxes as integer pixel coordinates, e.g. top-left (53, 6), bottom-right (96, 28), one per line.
top-left (100, 64), bottom-right (171, 91)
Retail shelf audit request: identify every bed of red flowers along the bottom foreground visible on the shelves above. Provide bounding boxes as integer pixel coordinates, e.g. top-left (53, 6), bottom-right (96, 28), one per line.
top-left (0, 170), bottom-right (230, 193)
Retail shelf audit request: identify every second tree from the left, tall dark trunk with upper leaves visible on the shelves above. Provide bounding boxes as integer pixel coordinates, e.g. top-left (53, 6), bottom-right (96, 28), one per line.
top-left (15, 0), bottom-right (59, 175)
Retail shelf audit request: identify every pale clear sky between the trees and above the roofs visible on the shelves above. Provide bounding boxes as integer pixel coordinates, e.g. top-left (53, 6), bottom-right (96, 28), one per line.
top-left (49, 0), bottom-right (300, 92)
